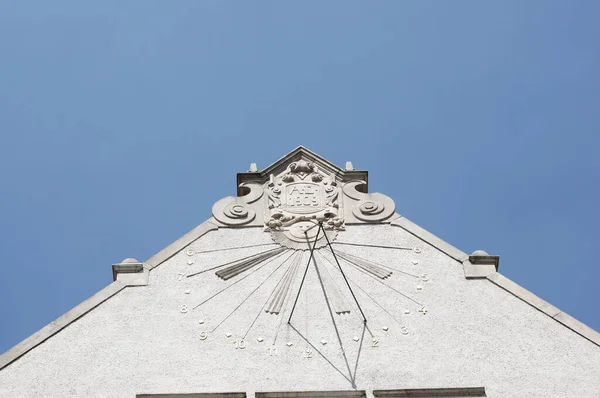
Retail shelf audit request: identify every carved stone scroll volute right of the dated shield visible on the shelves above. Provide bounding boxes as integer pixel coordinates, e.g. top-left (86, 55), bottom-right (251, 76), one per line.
top-left (343, 181), bottom-right (396, 223)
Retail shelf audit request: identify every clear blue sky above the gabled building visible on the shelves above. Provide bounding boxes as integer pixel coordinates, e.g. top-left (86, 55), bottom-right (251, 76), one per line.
top-left (0, 0), bottom-right (600, 352)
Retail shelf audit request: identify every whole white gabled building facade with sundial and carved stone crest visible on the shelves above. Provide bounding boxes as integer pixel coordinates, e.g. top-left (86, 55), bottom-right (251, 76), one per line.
top-left (0, 147), bottom-right (600, 398)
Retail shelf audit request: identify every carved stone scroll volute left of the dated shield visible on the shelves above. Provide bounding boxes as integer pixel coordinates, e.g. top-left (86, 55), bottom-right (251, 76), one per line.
top-left (212, 183), bottom-right (264, 226)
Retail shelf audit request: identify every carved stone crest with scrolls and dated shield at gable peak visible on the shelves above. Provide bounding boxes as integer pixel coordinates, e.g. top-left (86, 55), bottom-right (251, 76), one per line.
top-left (213, 147), bottom-right (395, 250)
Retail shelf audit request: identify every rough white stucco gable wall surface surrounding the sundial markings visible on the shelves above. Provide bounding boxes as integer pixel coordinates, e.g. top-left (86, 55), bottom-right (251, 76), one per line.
top-left (0, 225), bottom-right (600, 398)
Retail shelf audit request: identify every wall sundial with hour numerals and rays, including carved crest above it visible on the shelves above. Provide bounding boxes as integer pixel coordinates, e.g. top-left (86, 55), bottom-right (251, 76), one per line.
top-left (171, 159), bottom-right (431, 385)
